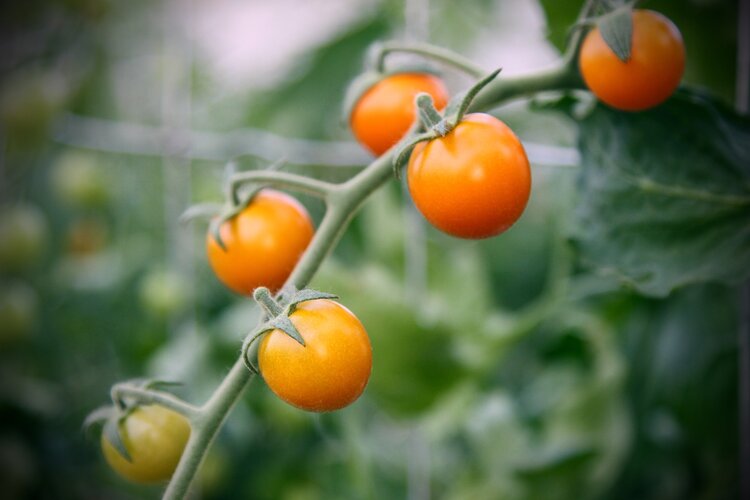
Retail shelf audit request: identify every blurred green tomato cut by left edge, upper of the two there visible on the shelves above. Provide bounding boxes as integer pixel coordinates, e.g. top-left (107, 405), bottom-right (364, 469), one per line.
top-left (0, 205), bottom-right (48, 272)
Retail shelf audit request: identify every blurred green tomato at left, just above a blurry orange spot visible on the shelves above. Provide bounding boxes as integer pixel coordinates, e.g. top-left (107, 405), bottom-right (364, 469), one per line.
top-left (51, 151), bottom-right (111, 208)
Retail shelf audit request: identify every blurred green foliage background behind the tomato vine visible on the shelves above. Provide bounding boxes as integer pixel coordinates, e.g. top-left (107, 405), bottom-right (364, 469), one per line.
top-left (0, 0), bottom-right (739, 500)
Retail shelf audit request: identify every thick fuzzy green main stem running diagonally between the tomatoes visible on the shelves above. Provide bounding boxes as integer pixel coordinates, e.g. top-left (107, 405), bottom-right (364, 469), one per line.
top-left (157, 38), bottom-right (580, 500)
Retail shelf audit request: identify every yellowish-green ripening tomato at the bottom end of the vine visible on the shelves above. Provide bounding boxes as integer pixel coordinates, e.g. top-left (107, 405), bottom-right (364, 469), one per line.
top-left (101, 405), bottom-right (190, 483)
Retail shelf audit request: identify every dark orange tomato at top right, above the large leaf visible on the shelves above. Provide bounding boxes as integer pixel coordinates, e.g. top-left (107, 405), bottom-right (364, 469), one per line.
top-left (578, 10), bottom-right (685, 111)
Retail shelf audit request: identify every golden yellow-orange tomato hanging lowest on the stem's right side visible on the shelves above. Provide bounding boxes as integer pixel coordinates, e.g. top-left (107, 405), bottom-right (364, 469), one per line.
top-left (258, 299), bottom-right (372, 412)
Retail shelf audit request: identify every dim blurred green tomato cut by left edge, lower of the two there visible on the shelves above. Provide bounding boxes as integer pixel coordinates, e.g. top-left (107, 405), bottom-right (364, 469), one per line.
top-left (0, 283), bottom-right (39, 347)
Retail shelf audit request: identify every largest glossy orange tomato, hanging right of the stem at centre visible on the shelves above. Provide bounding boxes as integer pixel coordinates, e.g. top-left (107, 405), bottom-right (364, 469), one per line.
top-left (407, 113), bottom-right (531, 239)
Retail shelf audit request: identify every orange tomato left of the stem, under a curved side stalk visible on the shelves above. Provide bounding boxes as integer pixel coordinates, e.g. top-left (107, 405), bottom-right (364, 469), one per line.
top-left (206, 189), bottom-right (315, 295)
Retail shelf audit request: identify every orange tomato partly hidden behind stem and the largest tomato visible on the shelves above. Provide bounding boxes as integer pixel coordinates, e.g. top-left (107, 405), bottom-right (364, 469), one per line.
top-left (351, 73), bottom-right (448, 156)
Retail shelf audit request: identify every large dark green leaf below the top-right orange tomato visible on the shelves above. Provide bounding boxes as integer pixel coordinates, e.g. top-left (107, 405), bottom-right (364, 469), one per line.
top-left (573, 92), bottom-right (750, 296)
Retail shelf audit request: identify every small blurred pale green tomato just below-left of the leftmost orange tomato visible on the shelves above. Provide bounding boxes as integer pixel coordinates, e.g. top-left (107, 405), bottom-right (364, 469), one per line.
top-left (139, 270), bottom-right (191, 319)
